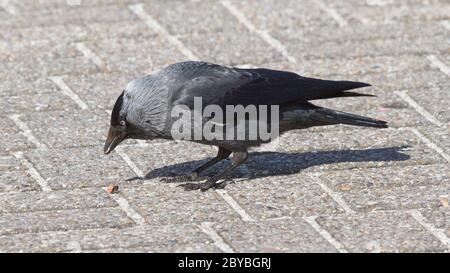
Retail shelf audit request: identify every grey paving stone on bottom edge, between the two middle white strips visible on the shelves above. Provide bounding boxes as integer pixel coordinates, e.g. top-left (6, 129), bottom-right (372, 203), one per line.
top-left (214, 219), bottom-right (337, 252)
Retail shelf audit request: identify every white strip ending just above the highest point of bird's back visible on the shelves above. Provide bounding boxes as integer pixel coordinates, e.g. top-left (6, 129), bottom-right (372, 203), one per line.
top-left (128, 3), bottom-right (199, 60)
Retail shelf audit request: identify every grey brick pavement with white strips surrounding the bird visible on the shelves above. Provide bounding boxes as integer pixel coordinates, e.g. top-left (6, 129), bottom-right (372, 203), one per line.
top-left (0, 0), bottom-right (450, 252)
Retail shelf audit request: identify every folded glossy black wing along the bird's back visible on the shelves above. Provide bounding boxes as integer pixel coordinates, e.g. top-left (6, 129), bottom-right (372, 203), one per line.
top-left (172, 63), bottom-right (369, 107)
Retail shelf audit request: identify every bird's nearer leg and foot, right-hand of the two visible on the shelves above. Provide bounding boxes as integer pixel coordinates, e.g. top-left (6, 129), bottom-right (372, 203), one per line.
top-left (180, 151), bottom-right (248, 191)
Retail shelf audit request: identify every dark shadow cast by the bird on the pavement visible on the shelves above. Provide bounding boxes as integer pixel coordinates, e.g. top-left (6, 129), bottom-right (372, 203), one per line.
top-left (128, 146), bottom-right (410, 181)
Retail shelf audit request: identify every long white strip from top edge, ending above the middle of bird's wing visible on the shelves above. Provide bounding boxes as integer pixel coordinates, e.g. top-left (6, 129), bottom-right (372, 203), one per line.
top-left (220, 1), bottom-right (296, 63)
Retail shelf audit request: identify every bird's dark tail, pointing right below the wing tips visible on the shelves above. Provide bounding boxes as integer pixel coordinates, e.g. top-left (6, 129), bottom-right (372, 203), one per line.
top-left (311, 108), bottom-right (388, 128)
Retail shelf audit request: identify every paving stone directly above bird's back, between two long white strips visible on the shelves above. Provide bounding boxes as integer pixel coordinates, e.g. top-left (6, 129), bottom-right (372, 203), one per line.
top-left (145, 1), bottom-right (282, 65)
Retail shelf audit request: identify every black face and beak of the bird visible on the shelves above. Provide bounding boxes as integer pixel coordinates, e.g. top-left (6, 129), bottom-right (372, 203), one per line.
top-left (103, 91), bottom-right (130, 154)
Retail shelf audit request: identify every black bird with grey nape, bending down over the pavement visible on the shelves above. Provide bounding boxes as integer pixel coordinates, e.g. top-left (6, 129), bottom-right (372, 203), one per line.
top-left (104, 61), bottom-right (387, 190)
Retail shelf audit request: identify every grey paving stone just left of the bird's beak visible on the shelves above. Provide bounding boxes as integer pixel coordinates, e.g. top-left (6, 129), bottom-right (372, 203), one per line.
top-left (21, 110), bottom-right (110, 148)
